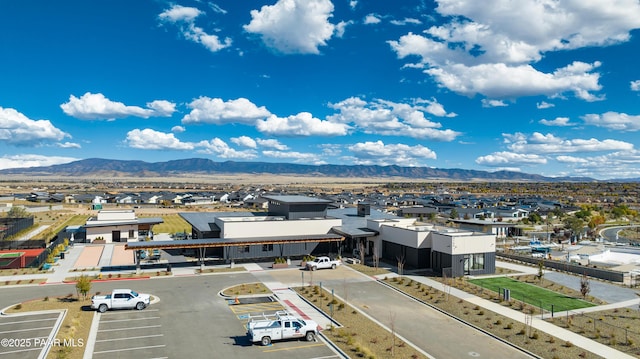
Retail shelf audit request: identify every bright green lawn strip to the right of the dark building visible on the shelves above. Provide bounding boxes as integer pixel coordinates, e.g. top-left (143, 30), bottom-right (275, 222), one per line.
top-left (469, 277), bottom-right (595, 312)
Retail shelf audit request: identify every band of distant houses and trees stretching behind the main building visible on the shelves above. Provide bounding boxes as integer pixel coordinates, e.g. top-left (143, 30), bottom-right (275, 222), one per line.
top-left (16, 188), bottom-right (577, 220)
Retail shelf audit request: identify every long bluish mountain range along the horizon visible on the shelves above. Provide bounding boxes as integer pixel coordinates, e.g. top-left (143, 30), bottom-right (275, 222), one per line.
top-left (0, 158), bottom-right (593, 182)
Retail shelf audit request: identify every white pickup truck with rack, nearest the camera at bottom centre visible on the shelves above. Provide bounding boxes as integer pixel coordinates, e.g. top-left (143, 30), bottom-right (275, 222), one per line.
top-left (247, 311), bottom-right (318, 345)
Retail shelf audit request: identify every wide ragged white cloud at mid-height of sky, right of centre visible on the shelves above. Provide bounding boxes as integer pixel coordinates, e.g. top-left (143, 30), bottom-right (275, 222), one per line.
top-left (327, 97), bottom-right (460, 141)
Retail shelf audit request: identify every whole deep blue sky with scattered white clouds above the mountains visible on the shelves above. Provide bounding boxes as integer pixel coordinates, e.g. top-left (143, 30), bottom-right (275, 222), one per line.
top-left (0, 0), bottom-right (640, 179)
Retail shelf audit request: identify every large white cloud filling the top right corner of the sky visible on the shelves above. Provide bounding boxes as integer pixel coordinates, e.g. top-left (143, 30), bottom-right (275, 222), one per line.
top-left (428, 0), bottom-right (640, 63)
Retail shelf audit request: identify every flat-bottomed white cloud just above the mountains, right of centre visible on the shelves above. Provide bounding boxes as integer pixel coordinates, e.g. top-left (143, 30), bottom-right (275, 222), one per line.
top-left (347, 141), bottom-right (437, 167)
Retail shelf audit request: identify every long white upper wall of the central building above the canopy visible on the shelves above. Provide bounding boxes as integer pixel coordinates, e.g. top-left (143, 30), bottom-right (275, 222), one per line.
top-left (215, 217), bottom-right (342, 238)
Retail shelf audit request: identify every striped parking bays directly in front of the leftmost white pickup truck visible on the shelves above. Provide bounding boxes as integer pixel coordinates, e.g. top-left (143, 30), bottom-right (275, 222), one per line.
top-left (90, 308), bottom-right (166, 359)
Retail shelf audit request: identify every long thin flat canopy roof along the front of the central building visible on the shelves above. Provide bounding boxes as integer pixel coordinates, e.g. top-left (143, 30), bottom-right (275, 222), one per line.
top-left (124, 233), bottom-right (344, 250)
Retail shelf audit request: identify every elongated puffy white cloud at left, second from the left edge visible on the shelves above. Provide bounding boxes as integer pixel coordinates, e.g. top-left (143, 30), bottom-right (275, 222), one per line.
top-left (60, 92), bottom-right (176, 120)
